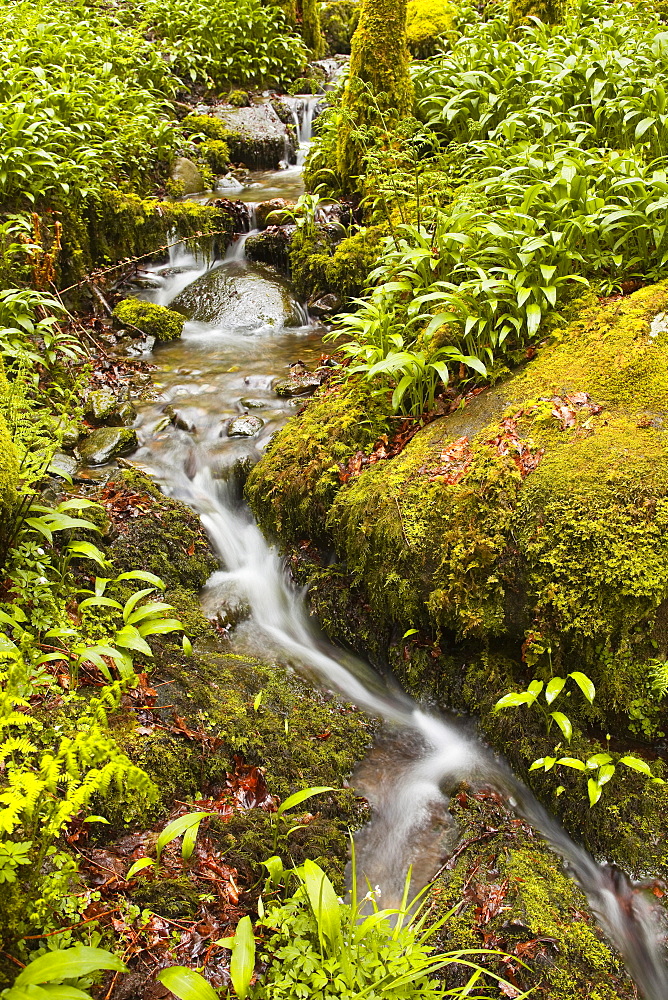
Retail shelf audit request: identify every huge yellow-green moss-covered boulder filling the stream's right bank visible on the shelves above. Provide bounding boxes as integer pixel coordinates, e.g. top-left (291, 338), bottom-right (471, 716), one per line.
top-left (248, 283), bottom-right (668, 872)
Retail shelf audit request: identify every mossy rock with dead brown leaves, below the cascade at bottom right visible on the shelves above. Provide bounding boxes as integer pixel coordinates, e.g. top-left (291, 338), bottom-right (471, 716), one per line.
top-left (431, 790), bottom-right (636, 1000)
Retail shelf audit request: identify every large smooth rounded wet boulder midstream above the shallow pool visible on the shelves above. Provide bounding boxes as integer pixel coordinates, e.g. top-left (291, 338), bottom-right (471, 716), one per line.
top-left (172, 266), bottom-right (302, 330)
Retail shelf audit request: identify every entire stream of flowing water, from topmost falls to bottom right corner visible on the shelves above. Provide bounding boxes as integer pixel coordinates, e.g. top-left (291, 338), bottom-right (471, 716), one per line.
top-left (121, 99), bottom-right (668, 1000)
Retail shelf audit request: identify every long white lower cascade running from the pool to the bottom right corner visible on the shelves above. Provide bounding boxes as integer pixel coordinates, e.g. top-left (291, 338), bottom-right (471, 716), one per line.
top-left (141, 452), bottom-right (668, 1000)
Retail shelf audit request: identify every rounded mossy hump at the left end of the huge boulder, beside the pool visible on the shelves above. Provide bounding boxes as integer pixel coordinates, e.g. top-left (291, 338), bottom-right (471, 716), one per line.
top-left (246, 379), bottom-right (388, 541)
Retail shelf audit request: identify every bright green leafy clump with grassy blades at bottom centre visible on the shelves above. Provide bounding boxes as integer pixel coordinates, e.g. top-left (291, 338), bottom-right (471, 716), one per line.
top-left (158, 857), bottom-right (524, 1000)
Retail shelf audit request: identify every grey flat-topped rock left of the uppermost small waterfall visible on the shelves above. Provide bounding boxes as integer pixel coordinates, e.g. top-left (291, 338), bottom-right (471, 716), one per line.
top-left (216, 103), bottom-right (296, 170)
